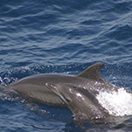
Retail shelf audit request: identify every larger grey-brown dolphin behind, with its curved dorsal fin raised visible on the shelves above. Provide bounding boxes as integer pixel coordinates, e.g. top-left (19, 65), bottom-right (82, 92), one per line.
top-left (7, 63), bottom-right (118, 106)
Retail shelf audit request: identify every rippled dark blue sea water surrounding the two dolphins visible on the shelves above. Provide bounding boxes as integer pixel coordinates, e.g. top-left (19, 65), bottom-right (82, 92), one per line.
top-left (0, 0), bottom-right (132, 132)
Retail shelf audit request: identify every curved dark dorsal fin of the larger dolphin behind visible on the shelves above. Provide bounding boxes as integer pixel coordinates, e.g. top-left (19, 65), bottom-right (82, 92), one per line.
top-left (77, 63), bottom-right (104, 81)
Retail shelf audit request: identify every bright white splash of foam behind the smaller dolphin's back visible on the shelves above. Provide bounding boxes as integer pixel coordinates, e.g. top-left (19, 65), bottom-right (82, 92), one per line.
top-left (97, 88), bottom-right (132, 116)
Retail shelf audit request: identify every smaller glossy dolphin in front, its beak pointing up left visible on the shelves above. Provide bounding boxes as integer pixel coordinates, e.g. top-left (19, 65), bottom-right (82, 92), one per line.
top-left (46, 83), bottom-right (108, 122)
